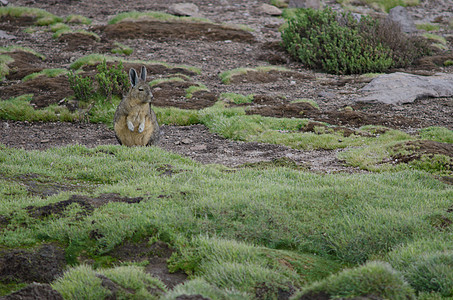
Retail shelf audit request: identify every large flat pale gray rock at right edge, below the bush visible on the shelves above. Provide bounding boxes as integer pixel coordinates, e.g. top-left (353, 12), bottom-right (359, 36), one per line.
top-left (356, 72), bottom-right (453, 104)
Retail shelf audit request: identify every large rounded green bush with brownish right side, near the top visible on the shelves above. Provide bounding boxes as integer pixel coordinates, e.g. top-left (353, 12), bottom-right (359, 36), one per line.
top-left (282, 8), bottom-right (429, 74)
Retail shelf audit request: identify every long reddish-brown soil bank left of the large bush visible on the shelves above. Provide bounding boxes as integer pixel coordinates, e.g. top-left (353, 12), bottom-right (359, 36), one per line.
top-left (99, 21), bottom-right (255, 43)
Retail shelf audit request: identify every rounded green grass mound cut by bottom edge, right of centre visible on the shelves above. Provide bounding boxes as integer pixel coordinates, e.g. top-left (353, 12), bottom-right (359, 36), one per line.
top-left (296, 262), bottom-right (415, 300)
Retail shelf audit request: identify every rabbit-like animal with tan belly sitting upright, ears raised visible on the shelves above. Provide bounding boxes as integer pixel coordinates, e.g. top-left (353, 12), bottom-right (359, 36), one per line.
top-left (113, 67), bottom-right (160, 147)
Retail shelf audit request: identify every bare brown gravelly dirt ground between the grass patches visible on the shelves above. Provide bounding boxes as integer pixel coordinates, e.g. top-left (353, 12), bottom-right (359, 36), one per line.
top-left (0, 0), bottom-right (453, 299)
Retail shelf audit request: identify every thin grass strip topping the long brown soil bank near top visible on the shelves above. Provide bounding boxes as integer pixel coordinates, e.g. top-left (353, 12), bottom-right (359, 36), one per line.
top-left (108, 11), bottom-right (212, 24)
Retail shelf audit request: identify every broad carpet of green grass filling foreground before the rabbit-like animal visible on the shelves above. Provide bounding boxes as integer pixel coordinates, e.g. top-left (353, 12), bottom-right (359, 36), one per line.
top-left (0, 145), bottom-right (453, 298)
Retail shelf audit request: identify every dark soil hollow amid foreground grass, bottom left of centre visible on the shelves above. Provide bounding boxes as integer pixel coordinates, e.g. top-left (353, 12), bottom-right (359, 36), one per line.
top-left (109, 241), bottom-right (187, 289)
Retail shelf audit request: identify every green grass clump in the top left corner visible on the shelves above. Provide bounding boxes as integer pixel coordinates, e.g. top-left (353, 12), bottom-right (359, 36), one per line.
top-left (0, 6), bottom-right (62, 26)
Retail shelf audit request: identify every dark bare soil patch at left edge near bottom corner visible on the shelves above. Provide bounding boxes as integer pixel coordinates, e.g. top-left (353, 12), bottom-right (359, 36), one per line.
top-left (0, 244), bottom-right (66, 283)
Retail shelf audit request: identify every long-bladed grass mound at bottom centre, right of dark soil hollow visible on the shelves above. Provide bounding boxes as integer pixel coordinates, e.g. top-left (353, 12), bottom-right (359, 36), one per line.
top-left (170, 236), bottom-right (342, 298)
